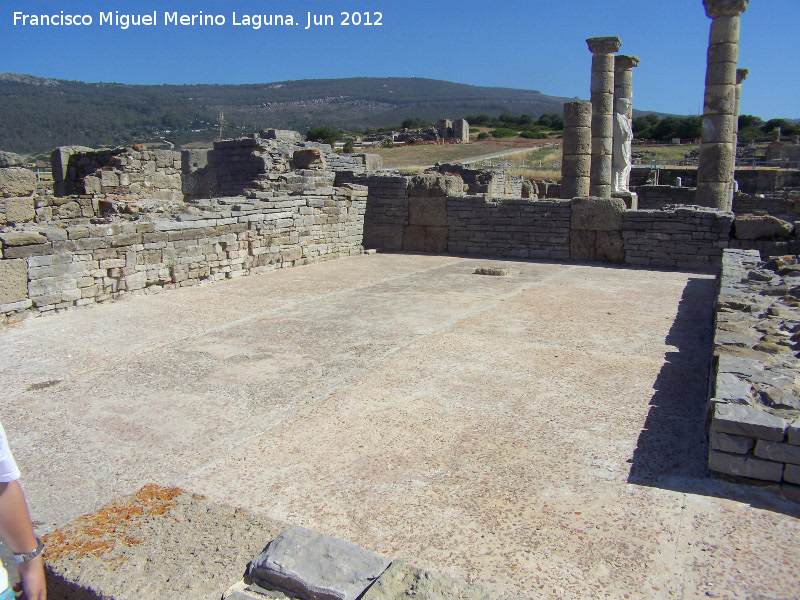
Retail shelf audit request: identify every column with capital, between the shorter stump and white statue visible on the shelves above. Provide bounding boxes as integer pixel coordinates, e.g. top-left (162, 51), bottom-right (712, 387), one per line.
top-left (586, 36), bottom-right (622, 198)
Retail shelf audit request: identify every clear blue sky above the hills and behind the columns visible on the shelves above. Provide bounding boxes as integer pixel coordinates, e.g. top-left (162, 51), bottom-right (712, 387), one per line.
top-left (0, 0), bottom-right (800, 119)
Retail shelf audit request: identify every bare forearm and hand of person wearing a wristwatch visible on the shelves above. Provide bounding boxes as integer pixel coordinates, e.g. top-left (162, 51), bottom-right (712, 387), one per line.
top-left (0, 481), bottom-right (47, 600)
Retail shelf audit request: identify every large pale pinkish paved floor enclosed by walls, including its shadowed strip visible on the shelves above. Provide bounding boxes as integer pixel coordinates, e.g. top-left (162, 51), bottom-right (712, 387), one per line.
top-left (0, 254), bottom-right (800, 600)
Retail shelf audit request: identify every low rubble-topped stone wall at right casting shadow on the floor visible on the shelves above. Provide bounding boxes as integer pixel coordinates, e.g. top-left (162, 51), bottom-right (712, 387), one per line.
top-left (708, 250), bottom-right (800, 501)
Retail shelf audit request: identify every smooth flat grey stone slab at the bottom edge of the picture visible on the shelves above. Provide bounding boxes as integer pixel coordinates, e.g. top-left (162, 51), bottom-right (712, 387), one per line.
top-left (249, 527), bottom-right (391, 600)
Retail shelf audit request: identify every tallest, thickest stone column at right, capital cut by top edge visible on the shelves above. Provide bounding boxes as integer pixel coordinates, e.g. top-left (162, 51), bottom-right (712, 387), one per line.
top-left (695, 0), bottom-right (750, 210)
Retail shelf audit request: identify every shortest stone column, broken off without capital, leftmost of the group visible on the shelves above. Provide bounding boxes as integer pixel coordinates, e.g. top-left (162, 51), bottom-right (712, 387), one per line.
top-left (561, 100), bottom-right (592, 199)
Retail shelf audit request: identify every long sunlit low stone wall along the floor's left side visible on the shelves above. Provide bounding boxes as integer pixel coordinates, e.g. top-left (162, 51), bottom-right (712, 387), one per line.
top-left (0, 186), bottom-right (367, 321)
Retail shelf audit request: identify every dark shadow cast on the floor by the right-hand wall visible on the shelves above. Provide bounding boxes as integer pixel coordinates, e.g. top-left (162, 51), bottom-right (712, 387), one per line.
top-left (628, 278), bottom-right (800, 517)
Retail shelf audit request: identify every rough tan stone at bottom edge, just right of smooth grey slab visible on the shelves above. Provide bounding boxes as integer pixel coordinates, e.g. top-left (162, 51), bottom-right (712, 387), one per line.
top-left (362, 561), bottom-right (489, 600)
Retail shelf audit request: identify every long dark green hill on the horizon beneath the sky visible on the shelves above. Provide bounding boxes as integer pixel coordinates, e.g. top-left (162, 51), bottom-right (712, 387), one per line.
top-left (0, 73), bottom-right (588, 154)
